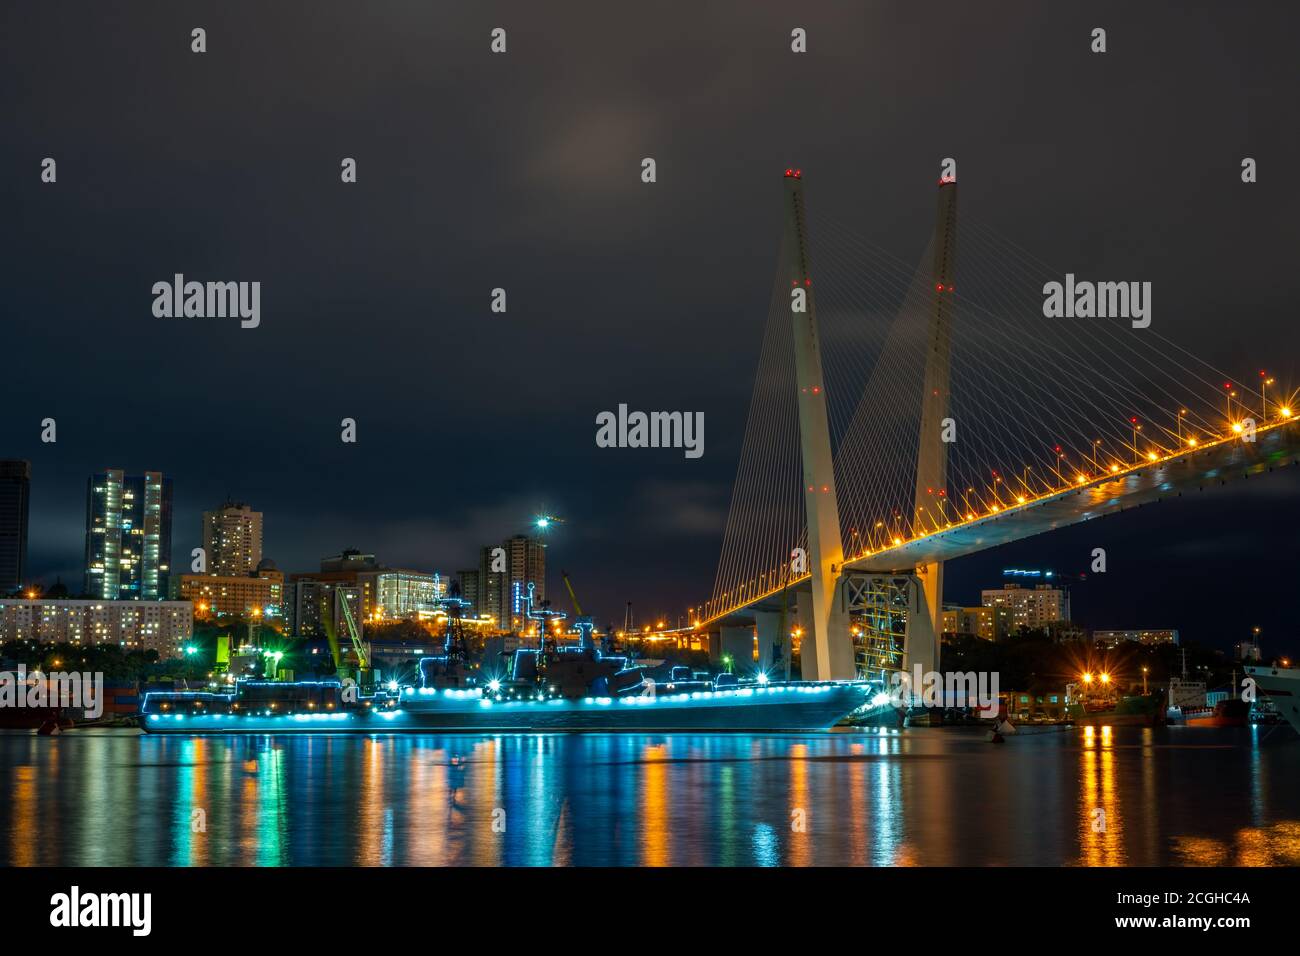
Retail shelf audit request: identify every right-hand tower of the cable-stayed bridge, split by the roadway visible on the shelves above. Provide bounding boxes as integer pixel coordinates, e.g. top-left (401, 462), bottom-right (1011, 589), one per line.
top-left (902, 176), bottom-right (957, 674)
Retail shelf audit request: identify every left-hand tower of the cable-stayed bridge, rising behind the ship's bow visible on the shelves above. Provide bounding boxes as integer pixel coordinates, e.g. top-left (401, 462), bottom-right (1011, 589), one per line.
top-left (785, 169), bottom-right (854, 680)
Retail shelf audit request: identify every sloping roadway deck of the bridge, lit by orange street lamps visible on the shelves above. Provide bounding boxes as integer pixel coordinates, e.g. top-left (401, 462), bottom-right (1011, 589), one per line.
top-left (699, 419), bottom-right (1300, 628)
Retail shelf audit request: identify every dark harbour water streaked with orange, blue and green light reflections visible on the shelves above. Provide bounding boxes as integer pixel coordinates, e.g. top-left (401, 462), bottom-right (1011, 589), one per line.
top-left (0, 727), bottom-right (1300, 866)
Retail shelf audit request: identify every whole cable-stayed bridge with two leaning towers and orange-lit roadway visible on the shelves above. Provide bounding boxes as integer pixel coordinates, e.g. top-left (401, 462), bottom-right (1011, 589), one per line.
top-left (692, 169), bottom-right (1300, 679)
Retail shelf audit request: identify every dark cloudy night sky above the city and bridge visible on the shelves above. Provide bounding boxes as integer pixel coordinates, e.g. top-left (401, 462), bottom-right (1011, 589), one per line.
top-left (0, 1), bottom-right (1300, 650)
